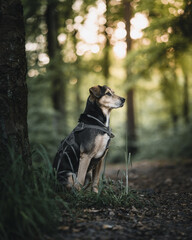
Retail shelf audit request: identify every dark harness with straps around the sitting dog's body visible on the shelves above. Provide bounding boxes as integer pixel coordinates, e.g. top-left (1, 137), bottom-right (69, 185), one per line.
top-left (53, 114), bottom-right (114, 182)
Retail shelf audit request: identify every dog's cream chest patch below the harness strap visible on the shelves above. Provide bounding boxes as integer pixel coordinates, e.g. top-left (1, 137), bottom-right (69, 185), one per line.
top-left (94, 134), bottom-right (109, 158)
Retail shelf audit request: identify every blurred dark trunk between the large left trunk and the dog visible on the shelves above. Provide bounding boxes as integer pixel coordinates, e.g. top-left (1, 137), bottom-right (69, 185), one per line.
top-left (46, 1), bottom-right (66, 132)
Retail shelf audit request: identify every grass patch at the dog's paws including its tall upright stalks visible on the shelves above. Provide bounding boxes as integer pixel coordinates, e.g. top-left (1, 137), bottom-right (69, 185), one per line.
top-left (57, 149), bottom-right (146, 220)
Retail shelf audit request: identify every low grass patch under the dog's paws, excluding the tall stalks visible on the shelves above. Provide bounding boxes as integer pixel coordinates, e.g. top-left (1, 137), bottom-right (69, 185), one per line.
top-left (60, 179), bottom-right (142, 210)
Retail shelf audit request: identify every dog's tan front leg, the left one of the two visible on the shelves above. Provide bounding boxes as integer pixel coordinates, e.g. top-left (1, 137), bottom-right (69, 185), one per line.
top-left (74, 153), bottom-right (91, 190)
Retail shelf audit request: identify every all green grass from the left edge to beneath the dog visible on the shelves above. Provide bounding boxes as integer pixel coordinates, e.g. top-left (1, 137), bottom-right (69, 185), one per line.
top-left (0, 143), bottom-right (143, 240)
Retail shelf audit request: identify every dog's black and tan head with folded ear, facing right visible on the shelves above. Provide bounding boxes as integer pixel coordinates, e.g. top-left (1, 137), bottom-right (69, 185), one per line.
top-left (89, 85), bottom-right (125, 110)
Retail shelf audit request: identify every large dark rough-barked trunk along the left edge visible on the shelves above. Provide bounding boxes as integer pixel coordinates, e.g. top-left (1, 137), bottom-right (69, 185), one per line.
top-left (0, 0), bottom-right (31, 164)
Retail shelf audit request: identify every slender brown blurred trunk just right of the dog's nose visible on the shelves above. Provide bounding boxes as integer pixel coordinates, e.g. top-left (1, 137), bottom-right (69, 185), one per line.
top-left (124, 0), bottom-right (137, 154)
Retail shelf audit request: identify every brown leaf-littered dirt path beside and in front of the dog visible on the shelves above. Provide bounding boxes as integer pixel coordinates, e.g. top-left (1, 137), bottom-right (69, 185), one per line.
top-left (46, 161), bottom-right (192, 240)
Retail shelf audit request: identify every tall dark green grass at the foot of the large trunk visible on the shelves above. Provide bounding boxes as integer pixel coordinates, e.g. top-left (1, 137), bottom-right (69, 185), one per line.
top-left (0, 144), bottom-right (64, 240)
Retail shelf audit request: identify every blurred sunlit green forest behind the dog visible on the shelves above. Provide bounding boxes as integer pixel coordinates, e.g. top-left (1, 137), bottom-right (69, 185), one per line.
top-left (22, 0), bottom-right (192, 162)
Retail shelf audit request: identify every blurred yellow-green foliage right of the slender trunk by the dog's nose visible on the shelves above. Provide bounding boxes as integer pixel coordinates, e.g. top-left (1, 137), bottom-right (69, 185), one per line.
top-left (127, 0), bottom-right (192, 161)
